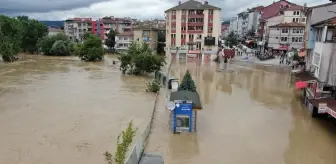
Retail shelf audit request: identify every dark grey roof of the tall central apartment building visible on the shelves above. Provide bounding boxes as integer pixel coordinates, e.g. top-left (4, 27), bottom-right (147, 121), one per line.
top-left (165, 0), bottom-right (221, 12)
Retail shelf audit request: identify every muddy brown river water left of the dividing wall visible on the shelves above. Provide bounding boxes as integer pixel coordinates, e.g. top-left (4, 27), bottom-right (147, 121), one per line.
top-left (0, 56), bottom-right (155, 164)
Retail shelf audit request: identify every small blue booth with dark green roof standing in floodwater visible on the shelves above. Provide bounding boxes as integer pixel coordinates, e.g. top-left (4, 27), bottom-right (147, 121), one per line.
top-left (168, 91), bottom-right (202, 133)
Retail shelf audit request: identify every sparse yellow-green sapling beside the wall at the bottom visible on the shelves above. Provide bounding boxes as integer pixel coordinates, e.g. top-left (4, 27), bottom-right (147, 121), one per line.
top-left (104, 121), bottom-right (137, 164)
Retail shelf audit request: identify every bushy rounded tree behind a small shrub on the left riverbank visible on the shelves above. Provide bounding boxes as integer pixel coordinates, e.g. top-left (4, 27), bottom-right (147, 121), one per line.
top-left (38, 33), bottom-right (70, 56)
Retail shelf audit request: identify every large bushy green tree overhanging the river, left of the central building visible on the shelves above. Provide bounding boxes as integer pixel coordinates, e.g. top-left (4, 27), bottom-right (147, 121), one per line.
top-left (119, 42), bottom-right (165, 75)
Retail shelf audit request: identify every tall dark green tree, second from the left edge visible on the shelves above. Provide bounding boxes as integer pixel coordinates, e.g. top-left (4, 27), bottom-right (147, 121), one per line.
top-left (17, 16), bottom-right (48, 53)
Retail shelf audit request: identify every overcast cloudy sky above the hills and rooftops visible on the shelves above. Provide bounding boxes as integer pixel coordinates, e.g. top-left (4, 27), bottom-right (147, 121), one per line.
top-left (0, 0), bottom-right (329, 20)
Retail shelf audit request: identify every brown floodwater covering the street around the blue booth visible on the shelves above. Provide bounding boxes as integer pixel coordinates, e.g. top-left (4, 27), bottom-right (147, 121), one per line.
top-left (146, 61), bottom-right (336, 164)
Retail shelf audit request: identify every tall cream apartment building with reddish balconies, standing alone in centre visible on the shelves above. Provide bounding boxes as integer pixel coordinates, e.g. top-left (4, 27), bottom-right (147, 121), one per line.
top-left (165, 0), bottom-right (221, 60)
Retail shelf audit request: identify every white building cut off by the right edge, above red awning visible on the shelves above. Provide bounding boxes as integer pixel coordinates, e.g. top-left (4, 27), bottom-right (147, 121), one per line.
top-left (305, 1), bottom-right (336, 85)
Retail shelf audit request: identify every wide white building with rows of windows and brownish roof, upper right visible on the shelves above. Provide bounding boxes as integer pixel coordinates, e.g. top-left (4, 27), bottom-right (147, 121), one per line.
top-left (267, 22), bottom-right (305, 52)
